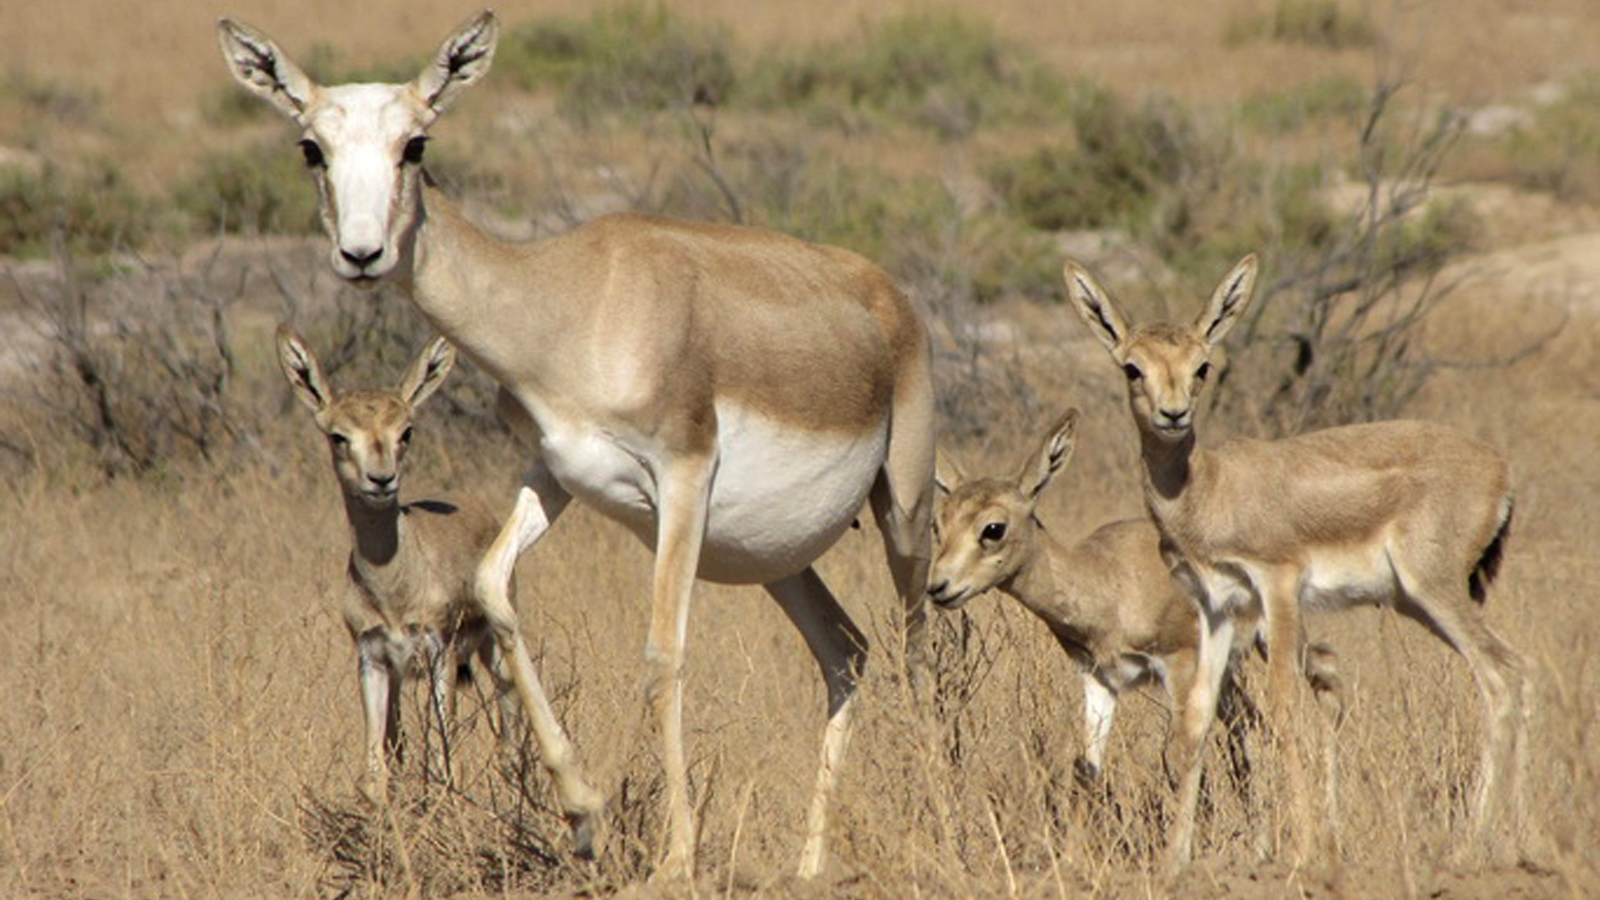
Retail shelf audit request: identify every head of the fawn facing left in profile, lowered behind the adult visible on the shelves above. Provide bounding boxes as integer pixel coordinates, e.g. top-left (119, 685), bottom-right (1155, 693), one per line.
top-left (928, 410), bottom-right (1078, 610)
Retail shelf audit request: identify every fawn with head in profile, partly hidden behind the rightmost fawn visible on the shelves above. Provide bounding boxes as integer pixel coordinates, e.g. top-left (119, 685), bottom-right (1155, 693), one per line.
top-left (928, 410), bottom-right (1342, 780)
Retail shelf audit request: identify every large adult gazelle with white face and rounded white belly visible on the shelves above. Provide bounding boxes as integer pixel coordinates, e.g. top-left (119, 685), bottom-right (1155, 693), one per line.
top-left (219, 13), bottom-right (934, 876)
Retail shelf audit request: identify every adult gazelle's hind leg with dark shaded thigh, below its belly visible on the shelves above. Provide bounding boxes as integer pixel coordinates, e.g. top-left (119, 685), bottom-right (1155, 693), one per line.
top-left (766, 569), bottom-right (867, 878)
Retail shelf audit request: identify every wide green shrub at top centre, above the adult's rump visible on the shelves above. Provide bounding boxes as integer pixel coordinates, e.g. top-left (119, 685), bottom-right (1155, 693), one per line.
top-left (750, 10), bottom-right (1064, 138)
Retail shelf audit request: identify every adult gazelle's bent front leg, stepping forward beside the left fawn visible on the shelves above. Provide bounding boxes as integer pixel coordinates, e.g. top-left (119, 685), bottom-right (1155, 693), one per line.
top-left (477, 463), bottom-right (605, 857)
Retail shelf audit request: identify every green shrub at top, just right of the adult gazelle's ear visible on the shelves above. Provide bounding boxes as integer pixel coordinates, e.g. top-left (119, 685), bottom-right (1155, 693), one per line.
top-left (494, 2), bottom-right (734, 122)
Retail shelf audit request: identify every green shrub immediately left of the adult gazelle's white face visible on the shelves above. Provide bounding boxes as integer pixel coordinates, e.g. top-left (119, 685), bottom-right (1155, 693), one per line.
top-left (173, 141), bottom-right (317, 234)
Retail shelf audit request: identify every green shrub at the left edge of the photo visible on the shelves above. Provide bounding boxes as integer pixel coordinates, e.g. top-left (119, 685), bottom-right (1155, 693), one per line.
top-left (0, 162), bottom-right (150, 256)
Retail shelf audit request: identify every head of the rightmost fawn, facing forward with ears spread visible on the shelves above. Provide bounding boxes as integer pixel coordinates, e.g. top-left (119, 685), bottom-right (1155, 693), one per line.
top-left (1062, 253), bottom-right (1256, 444)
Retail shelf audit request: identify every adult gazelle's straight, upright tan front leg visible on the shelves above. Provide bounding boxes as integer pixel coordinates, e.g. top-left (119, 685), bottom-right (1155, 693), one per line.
top-left (645, 448), bottom-right (717, 879)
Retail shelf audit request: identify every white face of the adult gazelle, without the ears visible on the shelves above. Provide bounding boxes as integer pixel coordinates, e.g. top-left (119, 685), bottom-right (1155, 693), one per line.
top-left (301, 85), bottom-right (434, 280)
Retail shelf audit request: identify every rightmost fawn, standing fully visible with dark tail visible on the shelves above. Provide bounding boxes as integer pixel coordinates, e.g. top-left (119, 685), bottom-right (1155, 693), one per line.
top-left (1064, 255), bottom-right (1531, 866)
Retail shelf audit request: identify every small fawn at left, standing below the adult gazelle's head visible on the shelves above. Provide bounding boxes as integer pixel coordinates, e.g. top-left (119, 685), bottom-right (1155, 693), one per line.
top-left (277, 327), bottom-right (512, 801)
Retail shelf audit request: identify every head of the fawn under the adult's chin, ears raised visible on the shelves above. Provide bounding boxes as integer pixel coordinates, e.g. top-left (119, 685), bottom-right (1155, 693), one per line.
top-left (278, 325), bottom-right (456, 509)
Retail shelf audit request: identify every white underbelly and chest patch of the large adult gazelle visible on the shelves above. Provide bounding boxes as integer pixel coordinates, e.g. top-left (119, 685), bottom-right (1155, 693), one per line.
top-left (542, 398), bottom-right (888, 583)
